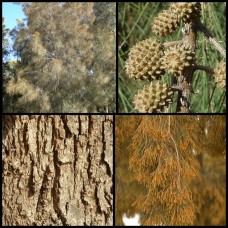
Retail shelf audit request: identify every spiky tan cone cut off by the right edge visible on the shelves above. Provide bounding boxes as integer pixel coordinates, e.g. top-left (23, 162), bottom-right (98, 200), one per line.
top-left (214, 61), bottom-right (226, 90)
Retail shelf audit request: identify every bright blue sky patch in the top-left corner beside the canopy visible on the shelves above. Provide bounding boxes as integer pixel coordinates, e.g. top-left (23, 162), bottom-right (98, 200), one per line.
top-left (2, 2), bottom-right (25, 29)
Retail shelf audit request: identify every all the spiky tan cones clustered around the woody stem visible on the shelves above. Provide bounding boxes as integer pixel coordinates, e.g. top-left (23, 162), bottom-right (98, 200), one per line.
top-left (126, 2), bottom-right (226, 113)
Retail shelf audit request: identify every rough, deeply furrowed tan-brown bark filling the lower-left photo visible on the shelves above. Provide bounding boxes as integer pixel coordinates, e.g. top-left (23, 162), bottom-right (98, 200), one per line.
top-left (2, 115), bottom-right (113, 226)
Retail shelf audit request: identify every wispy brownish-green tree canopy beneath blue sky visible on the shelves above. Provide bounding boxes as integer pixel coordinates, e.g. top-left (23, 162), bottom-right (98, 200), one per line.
top-left (4, 2), bottom-right (116, 112)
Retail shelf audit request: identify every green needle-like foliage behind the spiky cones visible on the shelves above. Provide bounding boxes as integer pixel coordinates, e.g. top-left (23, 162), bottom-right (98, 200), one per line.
top-left (118, 2), bottom-right (226, 113)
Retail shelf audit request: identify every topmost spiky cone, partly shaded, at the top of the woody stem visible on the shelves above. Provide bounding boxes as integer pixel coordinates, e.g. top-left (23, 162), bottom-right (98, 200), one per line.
top-left (169, 2), bottom-right (201, 23)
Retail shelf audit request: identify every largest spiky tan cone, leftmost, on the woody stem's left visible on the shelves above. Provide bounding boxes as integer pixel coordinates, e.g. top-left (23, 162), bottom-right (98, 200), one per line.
top-left (126, 39), bottom-right (164, 81)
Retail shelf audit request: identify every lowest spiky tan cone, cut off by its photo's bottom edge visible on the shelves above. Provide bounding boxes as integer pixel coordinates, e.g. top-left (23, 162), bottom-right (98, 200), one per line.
top-left (133, 81), bottom-right (173, 113)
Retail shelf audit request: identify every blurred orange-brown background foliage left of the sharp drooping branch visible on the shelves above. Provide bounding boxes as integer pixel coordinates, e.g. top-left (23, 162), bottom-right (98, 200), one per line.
top-left (115, 116), bottom-right (145, 225)
